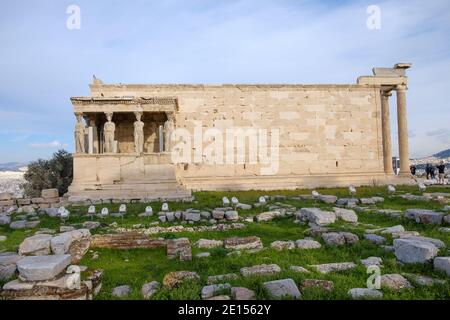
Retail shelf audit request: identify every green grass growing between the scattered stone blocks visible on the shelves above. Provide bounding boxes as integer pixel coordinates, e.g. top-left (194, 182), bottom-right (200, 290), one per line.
top-left (0, 186), bottom-right (450, 300)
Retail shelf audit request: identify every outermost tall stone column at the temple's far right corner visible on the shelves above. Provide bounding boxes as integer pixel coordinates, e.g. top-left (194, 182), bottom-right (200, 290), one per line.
top-left (396, 85), bottom-right (410, 174)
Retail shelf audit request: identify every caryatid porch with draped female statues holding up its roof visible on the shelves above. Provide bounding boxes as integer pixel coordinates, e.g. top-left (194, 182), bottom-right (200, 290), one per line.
top-left (69, 97), bottom-right (190, 199)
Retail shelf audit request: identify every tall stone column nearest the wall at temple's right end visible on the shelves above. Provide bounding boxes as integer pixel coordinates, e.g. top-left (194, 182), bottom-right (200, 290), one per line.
top-left (381, 91), bottom-right (394, 174)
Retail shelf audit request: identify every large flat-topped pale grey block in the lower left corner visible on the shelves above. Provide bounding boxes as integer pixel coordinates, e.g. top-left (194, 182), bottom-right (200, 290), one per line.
top-left (17, 254), bottom-right (71, 281)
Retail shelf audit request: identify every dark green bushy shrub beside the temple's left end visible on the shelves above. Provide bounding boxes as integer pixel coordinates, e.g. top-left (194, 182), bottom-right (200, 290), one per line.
top-left (23, 150), bottom-right (73, 197)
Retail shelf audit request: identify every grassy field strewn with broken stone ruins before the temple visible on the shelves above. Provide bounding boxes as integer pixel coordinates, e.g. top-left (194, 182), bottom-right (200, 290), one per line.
top-left (0, 186), bottom-right (450, 300)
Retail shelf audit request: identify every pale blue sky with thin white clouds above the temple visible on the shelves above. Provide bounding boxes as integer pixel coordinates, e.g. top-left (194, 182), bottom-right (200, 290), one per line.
top-left (0, 0), bottom-right (450, 162)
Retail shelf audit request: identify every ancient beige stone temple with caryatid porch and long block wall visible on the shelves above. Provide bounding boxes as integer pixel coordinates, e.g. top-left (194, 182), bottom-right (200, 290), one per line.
top-left (65, 64), bottom-right (410, 199)
